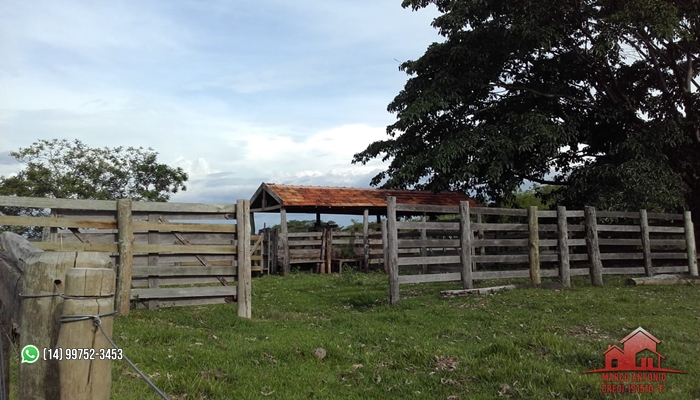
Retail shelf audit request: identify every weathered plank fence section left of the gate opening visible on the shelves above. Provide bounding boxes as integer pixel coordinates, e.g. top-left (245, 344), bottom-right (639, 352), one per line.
top-left (0, 196), bottom-right (252, 317)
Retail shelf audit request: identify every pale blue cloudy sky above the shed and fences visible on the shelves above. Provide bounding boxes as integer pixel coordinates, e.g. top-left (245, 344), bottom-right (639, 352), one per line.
top-left (0, 0), bottom-right (441, 225)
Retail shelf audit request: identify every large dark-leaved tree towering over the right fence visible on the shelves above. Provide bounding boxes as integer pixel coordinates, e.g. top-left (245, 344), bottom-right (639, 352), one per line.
top-left (353, 0), bottom-right (700, 224)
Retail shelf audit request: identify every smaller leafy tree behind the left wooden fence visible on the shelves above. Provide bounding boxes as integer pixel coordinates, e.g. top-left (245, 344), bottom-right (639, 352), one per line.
top-left (0, 139), bottom-right (188, 235)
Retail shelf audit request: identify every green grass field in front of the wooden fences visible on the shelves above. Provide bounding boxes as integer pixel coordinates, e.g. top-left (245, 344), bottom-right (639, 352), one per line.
top-left (6, 272), bottom-right (700, 400)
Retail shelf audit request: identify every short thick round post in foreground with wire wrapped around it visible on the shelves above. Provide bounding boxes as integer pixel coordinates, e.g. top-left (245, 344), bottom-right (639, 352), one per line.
top-left (56, 268), bottom-right (116, 400)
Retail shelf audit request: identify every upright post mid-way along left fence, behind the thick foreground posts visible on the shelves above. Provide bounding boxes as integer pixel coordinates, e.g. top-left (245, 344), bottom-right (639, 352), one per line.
top-left (115, 199), bottom-right (134, 315)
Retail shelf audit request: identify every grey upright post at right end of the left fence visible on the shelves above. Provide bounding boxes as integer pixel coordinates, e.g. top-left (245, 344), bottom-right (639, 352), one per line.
top-left (236, 200), bottom-right (251, 318)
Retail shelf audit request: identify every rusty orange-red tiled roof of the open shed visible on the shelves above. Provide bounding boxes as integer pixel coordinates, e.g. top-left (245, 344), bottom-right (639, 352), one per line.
top-left (250, 183), bottom-right (479, 215)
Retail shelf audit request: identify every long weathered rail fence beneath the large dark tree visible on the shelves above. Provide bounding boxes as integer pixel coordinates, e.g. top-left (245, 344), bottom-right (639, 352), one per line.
top-left (384, 197), bottom-right (698, 304)
